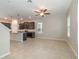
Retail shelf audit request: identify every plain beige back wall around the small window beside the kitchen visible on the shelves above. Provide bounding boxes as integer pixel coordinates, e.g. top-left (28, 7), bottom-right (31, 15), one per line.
top-left (35, 15), bottom-right (67, 40)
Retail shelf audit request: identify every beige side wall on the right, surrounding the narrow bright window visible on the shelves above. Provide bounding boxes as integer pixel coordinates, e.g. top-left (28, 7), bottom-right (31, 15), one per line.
top-left (68, 0), bottom-right (78, 56)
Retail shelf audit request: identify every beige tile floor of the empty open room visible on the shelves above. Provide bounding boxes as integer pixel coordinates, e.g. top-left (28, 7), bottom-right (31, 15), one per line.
top-left (3, 39), bottom-right (77, 59)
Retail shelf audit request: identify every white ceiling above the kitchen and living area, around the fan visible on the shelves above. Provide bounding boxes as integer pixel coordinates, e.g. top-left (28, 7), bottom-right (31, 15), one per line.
top-left (0, 0), bottom-right (71, 18)
